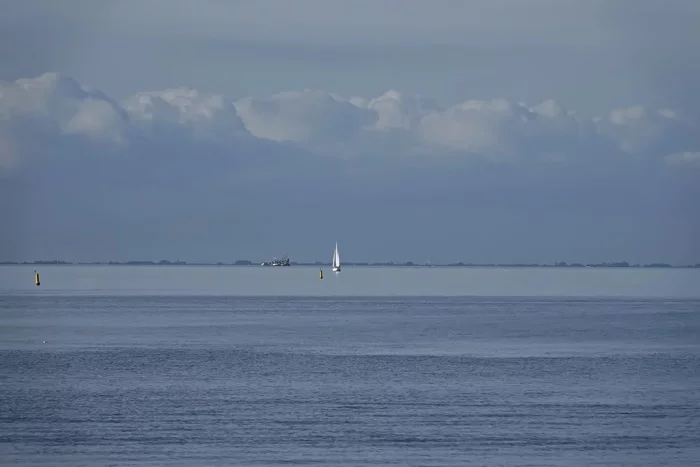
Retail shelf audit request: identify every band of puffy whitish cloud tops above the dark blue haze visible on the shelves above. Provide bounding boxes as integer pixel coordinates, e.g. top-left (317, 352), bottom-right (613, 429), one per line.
top-left (0, 73), bottom-right (700, 170)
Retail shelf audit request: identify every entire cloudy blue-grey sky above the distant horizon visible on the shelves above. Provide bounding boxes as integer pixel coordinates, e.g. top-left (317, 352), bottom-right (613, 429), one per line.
top-left (0, 0), bottom-right (700, 264)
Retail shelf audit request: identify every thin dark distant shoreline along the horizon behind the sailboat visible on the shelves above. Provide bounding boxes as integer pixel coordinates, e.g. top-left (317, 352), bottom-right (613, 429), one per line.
top-left (0, 260), bottom-right (700, 269)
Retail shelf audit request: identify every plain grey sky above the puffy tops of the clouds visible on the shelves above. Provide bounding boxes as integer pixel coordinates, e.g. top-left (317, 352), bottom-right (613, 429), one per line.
top-left (5, 0), bottom-right (700, 113)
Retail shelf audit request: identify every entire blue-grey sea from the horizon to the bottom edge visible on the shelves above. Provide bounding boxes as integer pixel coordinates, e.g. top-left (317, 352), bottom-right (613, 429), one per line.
top-left (0, 265), bottom-right (700, 467)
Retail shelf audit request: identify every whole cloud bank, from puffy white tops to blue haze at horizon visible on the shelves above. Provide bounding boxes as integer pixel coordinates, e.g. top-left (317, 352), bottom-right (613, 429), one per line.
top-left (0, 73), bottom-right (700, 261)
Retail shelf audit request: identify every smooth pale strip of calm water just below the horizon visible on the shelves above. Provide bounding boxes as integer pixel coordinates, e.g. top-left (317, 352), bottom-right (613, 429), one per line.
top-left (0, 266), bottom-right (700, 298)
